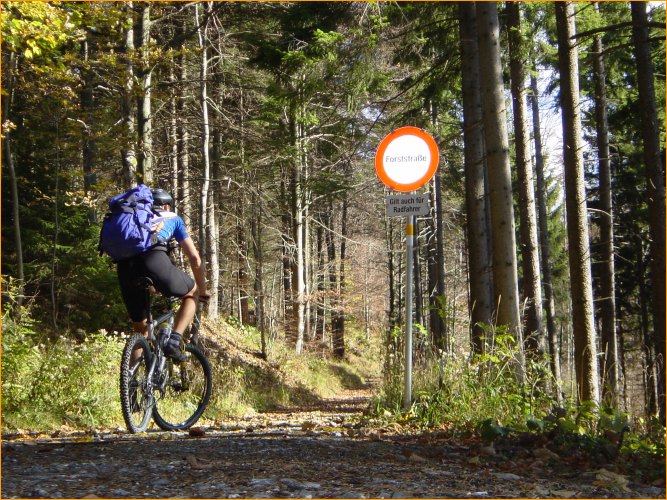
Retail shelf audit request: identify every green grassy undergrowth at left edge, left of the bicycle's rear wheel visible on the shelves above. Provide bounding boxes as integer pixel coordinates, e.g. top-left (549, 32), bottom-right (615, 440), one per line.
top-left (2, 294), bottom-right (122, 430)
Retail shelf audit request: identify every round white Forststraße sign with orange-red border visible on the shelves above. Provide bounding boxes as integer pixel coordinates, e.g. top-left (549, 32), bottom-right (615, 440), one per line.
top-left (375, 127), bottom-right (439, 192)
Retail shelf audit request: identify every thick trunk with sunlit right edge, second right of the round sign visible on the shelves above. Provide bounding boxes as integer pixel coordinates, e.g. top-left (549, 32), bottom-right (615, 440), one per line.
top-left (476, 2), bottom-right (523, 352)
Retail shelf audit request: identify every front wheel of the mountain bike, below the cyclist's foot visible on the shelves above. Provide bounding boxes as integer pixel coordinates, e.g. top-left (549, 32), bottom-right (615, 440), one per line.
top-left (153, 344), bottom-right (213, 431)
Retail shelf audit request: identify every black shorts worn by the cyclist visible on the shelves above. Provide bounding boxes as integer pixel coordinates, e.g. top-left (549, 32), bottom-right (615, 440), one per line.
top-left (117, 249), bottom-right (195, 322)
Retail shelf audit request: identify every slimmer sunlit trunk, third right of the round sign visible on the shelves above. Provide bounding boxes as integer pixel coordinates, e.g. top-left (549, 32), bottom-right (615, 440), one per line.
top-left (506, 2), bottom-right (546, 356)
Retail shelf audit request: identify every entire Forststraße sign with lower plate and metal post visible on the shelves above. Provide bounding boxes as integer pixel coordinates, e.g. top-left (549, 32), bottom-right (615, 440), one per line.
top-left (375, 127), bottom-right (439, 410)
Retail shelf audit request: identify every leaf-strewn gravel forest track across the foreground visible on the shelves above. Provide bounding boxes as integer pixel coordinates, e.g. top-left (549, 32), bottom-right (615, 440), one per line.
top-left (2, 376), bottom-right (665, 498)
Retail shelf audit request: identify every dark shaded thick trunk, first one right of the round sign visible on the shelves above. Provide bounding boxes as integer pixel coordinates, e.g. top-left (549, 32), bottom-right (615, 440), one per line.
top-left (459, 1), bottom-right (493, 354)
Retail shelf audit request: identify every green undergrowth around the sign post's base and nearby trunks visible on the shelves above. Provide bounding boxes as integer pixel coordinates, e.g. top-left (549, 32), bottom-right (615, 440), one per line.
top-left (375, 326), bottom-right (553, 430)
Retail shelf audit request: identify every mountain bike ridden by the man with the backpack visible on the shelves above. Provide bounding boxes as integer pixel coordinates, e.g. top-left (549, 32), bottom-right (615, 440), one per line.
top-left (120, 278), bottom-right (212, 433)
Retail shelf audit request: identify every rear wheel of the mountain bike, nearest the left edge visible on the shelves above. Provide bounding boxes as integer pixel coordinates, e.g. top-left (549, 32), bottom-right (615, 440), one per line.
top-left (120, 333), bottom-right (155, 433)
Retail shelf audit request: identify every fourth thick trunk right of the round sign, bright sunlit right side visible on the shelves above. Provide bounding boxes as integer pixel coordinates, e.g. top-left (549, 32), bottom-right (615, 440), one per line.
top-left (555, 2), bottom-right (600, 403)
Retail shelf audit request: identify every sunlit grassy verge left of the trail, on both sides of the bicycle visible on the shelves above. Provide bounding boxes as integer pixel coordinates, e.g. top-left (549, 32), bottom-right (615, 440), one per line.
top-left (2, 317), bottom-right (379, 434)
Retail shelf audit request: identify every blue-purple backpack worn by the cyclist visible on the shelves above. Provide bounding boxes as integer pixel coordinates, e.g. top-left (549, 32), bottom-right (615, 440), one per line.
top-left (99, 184), bottom-right (156, 262)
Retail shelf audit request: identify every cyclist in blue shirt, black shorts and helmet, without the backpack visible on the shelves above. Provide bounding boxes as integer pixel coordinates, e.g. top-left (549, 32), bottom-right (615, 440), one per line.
top-left (117, 189), bottom-right (209, 362)
